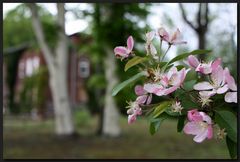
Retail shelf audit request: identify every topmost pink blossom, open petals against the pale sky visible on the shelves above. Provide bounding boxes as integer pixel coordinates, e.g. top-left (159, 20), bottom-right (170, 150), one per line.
top-left (158, 27), bottom-right (187, 45)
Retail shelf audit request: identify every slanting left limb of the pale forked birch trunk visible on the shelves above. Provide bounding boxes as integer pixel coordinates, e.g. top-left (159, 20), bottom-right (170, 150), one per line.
top-left (26, 3), bottom-right (53, 67)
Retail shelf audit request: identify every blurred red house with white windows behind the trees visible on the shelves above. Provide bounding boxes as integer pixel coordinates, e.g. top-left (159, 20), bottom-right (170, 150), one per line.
top-left (3, 34), bottom-right (91, 118)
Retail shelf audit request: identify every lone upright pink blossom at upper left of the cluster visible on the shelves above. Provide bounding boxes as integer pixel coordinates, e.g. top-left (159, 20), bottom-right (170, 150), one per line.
top-left (114, 36), bottom-right (134, 59)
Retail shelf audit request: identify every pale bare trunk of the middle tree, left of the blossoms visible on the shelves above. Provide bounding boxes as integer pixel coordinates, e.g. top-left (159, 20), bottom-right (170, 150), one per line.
top-left (103, 49), bottom-right (121, 137)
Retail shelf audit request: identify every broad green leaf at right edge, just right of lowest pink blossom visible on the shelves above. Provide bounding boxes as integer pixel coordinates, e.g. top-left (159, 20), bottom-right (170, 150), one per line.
top-left (215, 110), bottom-right (237, 143)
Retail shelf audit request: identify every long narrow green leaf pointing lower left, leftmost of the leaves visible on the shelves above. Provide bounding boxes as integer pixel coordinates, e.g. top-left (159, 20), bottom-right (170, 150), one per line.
top-left (112, 71), bottom-right (146, 96)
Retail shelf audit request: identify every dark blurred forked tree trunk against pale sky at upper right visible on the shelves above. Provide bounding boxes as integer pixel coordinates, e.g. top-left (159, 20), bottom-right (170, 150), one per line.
top-left (179, 3), bottom-right (209, 60)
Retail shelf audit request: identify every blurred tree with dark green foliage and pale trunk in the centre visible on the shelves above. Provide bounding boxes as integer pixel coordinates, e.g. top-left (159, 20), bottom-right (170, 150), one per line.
top-left (88, 3), bottom-right (151, 136)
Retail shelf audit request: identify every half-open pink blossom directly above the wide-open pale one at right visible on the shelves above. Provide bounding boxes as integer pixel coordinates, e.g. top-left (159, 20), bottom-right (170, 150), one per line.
top-left (187, 55), bottom-right (221, 74)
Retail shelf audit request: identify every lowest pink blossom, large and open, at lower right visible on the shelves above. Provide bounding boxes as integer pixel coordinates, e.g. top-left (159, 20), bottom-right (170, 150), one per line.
top-left (183, 109), bottom-right (213, 143)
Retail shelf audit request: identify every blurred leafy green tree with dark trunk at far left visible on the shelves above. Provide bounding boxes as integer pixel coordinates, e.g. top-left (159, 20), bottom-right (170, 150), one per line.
top-left (3, 4), bottom-right (55, 113)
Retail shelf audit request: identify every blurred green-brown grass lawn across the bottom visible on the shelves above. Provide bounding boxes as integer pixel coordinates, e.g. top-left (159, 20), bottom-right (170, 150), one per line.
top-left (3, 114), bottom-right (229, 159)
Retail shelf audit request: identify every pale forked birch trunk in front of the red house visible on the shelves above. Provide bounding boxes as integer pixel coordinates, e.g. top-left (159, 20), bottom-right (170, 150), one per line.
top-left (27, 3), bottom-right (74, 135)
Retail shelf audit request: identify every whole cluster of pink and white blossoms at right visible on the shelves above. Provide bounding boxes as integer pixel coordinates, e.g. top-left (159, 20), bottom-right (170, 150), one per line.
top-left (114, 27), bottom-right (237, 143)
